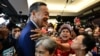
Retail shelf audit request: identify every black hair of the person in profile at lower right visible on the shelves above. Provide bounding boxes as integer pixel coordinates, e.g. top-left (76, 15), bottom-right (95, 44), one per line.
top-left (82, 33), bottom-right (96, 53)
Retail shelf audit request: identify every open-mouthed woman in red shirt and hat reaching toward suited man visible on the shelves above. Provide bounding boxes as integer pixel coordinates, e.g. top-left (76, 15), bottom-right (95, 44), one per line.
top-left (54, 24), bottom-right (74, 56)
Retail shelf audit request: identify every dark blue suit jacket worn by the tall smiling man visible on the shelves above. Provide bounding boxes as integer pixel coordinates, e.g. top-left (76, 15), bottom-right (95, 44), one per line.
top-left (18, 21), bottom-right (36, 56)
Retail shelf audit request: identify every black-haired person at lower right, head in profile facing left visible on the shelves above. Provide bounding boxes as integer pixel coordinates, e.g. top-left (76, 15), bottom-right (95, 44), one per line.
top-left (71, 34), bottom-right (96, 56)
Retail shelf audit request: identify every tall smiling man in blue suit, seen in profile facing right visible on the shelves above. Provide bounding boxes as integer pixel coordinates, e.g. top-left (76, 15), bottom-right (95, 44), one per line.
top-left (18, 2), bottom-right (49, 56)
